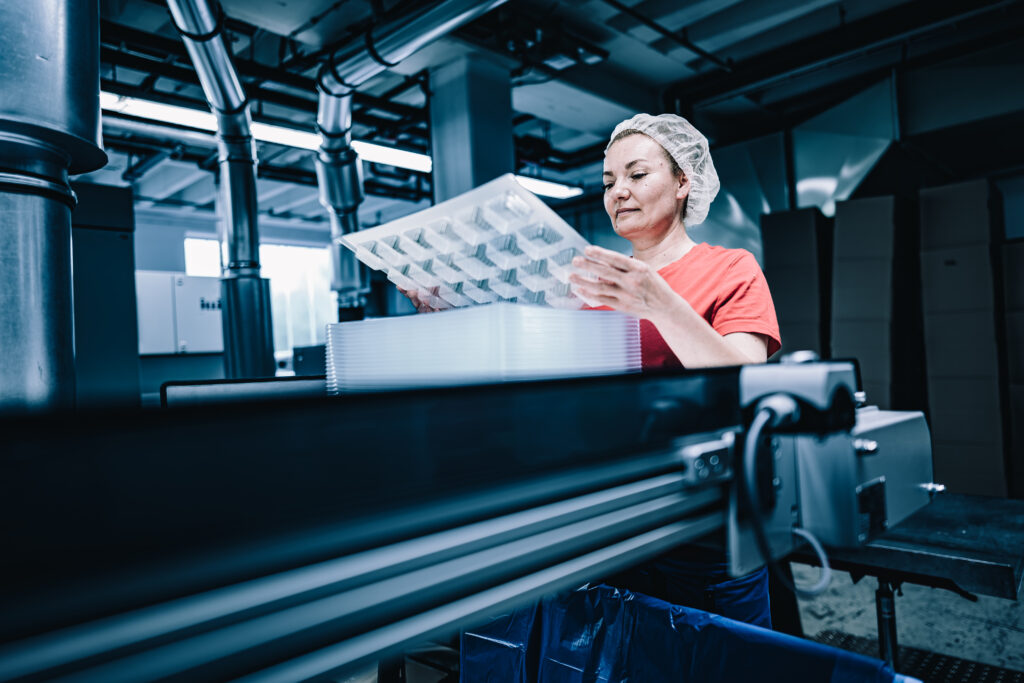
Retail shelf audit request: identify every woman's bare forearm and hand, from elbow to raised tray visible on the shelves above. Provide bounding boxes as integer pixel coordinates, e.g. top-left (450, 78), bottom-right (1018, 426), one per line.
top-left (570, 242), bottom-right (768, 368)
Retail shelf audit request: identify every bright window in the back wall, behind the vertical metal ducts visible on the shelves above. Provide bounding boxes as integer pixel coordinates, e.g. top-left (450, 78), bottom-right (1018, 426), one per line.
top-left (185, 238), bottom-right (336, 351)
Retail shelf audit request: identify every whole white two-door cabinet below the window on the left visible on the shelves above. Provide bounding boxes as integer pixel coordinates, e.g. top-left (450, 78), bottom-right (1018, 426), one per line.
top-left (135, 270), bottom-right (224, 355)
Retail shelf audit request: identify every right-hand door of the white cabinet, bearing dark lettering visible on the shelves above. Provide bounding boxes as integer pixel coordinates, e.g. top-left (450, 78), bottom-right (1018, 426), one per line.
top-left (174, 274), bottom-right (224, 353)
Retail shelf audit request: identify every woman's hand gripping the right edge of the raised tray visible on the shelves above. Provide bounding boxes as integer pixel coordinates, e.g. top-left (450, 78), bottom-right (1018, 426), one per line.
top-left (569, 246), bottom-right (684, 322)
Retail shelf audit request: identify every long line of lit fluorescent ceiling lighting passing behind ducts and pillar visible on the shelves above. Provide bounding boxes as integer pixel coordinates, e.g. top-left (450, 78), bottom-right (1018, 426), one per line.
top-left (99, 92), bottom-right (583, 199)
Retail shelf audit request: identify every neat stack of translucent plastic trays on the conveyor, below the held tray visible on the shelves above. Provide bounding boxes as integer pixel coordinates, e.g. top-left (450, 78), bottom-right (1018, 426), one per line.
top-left (327, 303), bottom-right (640, 394)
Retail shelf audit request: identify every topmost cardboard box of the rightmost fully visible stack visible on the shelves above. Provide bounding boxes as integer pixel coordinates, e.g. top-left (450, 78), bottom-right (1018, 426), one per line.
top-left (918, 180), bottom-right (992, 251)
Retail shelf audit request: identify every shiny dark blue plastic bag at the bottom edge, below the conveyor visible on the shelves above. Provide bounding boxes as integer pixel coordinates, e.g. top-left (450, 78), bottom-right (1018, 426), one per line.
top-left (461, 585), bottom-right (894, 683)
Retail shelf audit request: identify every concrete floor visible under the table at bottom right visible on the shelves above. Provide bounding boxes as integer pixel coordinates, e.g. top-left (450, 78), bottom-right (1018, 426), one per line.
top-left (793, 564), bottom-right (1024, 672)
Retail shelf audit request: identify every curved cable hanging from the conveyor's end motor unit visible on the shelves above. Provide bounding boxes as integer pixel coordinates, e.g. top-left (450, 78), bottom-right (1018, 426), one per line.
top-left (743, 394), bottom-right (831, 598)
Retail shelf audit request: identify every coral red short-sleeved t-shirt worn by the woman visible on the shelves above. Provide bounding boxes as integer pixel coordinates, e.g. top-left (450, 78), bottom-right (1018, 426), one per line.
top-left (601, 243), bottom-right (781, 370)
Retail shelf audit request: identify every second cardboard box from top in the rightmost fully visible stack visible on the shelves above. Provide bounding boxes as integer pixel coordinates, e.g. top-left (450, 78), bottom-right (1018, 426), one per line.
top-left (921, 246), bottom-right (995, 316)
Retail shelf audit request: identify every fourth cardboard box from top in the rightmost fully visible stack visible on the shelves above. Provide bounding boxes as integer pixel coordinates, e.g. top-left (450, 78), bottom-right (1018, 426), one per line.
top-left (928, 378), bottom-right (1002, 444)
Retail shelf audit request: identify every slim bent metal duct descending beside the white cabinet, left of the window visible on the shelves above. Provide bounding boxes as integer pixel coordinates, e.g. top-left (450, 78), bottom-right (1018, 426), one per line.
top-left (167, 0), bottom-right (274, 378)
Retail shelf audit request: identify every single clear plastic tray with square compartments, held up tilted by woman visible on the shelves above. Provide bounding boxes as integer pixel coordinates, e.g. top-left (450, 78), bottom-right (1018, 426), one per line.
top-left (339, 174), bottom-right (587, 309)
